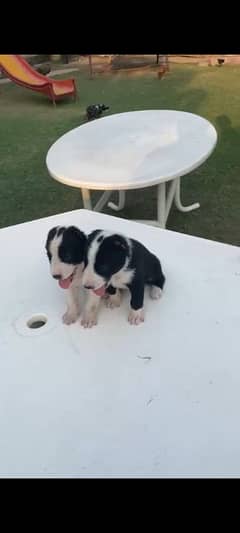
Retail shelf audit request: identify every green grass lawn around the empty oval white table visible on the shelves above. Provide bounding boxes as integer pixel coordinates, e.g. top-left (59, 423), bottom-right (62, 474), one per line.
top-left (0, 65), bottom-right (240, 245)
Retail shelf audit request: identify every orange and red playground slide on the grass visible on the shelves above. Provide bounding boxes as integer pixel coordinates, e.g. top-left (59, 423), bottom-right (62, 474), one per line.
top-left (0, 54), bottom-right (77, 104)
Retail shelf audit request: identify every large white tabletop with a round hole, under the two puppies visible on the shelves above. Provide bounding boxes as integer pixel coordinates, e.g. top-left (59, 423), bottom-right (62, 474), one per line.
top-left (0, 210), bottom-right (240, 477)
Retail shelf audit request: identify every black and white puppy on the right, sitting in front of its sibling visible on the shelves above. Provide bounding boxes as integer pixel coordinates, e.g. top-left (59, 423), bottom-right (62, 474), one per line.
top-left (82, 230), bottom-right (165, 327)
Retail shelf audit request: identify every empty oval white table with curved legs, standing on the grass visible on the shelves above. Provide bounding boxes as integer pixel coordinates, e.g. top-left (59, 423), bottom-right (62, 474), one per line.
top-left (46, 110), bottom-right (217, 227)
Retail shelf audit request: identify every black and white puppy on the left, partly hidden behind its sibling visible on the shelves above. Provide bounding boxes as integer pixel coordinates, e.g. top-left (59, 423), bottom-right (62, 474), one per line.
top-left (45, 226), bottom-right (87, 324)
